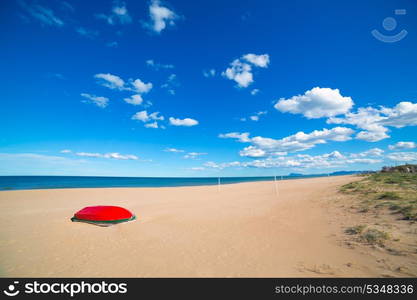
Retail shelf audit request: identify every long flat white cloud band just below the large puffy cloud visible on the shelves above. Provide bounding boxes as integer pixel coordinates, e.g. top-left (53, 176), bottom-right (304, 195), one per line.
top-left (219, 127), bottom-right (354, 156)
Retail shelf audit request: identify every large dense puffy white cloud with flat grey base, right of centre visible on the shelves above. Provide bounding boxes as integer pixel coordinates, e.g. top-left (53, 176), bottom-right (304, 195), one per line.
top-left (274, 87), bottom-right (353, 119)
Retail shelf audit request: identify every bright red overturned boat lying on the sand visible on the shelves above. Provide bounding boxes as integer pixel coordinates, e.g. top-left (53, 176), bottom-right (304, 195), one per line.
top-left (74, 205), bottom-right (133, 221)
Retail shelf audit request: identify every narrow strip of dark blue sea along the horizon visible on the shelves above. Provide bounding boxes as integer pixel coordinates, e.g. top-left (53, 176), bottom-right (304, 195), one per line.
top-left (0, 174), bottom-right (342, 191)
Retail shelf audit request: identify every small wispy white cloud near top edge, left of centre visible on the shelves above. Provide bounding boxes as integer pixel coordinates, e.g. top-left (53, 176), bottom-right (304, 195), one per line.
top-left (145, 0), bottom-right (178, 33)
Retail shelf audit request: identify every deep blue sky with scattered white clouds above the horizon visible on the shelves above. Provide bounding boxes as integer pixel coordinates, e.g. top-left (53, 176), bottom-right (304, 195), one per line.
top-left (0, 0), bottom-right (417, 176)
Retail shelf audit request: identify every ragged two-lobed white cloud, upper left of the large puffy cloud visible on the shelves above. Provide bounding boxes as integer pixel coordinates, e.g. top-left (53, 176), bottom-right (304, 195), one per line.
top-left (222, 54), bottom-right (269, 88)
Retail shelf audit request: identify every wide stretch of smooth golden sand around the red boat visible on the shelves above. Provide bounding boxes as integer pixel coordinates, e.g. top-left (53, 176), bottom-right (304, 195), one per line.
top-left (0, 176), bottom-right (417, 277)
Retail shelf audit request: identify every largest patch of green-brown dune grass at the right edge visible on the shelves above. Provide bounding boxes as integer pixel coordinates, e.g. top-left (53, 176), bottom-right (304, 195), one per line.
top-left (340, 172), bottom-right (417, 221)
